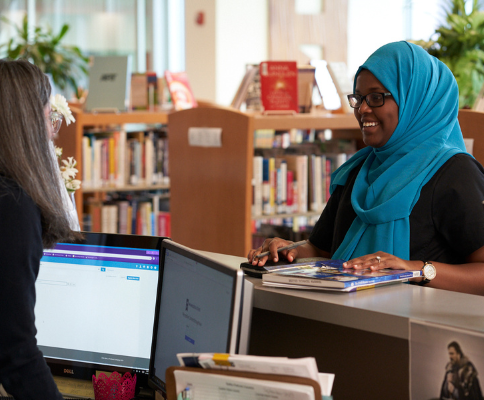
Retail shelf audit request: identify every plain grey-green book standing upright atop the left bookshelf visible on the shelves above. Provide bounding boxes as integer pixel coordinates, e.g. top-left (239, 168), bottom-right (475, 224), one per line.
top-left (85, 55), bottom-right (131, 112)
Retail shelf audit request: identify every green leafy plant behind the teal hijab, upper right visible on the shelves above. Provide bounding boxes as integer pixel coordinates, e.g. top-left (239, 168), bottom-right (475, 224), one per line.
top-left (413, 0), bottom-right (484, 108)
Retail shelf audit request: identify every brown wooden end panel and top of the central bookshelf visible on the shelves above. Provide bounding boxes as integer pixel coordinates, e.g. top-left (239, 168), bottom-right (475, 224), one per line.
top-left (168, 107), bottom-right (361, 256)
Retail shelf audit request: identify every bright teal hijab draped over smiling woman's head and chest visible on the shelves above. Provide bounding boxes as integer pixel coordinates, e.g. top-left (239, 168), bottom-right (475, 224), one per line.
top-left (330, 42), bottom-right (466, 260)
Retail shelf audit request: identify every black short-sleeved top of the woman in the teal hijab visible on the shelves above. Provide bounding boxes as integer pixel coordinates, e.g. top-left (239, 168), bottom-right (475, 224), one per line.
top-left (309, 154), bottom-right (484, 264)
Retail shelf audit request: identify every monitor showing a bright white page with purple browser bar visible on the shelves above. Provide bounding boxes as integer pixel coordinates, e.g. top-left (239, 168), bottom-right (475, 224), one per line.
top-left (35, 232), bottom-right (163, 388)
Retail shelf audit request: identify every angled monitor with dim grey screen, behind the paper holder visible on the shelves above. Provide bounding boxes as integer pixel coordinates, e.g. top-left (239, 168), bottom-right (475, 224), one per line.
top-left (148, 241), bottom-right (253, 396)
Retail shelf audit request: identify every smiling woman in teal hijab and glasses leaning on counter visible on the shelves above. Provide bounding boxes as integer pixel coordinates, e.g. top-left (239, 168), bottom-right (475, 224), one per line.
top-left (248, 42), bottom-right (484, 294)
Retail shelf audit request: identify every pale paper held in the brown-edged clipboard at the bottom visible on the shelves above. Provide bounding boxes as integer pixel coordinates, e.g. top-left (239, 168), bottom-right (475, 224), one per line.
top-left (174, 370), bottom-right (319, 400)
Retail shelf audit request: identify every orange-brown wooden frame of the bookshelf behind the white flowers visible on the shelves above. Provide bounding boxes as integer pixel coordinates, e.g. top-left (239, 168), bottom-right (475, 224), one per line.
top-left (55, 106), bottom-right (169, 229)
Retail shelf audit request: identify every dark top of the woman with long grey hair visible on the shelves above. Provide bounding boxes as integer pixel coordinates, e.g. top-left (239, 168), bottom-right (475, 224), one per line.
top-left (0, 176), bottom-right (62, 400)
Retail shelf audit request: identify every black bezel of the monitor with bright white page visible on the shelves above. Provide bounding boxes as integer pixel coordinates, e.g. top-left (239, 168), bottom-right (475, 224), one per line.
top-left (38, 232), bottom-right (166, 390)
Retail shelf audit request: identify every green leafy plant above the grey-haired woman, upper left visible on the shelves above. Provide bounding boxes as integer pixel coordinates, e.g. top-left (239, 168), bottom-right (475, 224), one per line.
top-left (0, 16), bottom-right (89, 98)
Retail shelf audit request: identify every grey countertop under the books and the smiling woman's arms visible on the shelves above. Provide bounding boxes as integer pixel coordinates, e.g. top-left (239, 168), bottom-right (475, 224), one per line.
top-left (202, 252), bottom-right (484, 339)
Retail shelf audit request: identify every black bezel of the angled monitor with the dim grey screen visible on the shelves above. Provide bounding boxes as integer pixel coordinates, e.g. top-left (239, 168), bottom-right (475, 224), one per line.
top-left (148, 241), bottom-right (246, 398)
